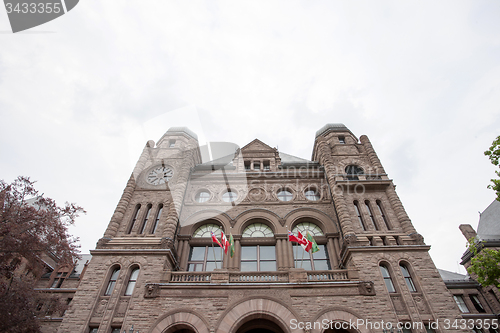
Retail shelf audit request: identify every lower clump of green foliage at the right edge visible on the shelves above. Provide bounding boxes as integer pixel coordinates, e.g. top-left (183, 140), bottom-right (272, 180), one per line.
top-left (467, 238), bottom-right (500, 288)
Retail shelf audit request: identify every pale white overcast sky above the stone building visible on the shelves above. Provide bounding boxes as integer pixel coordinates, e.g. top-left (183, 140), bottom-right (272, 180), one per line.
top-left (0, 0), bottom-right (500, 273)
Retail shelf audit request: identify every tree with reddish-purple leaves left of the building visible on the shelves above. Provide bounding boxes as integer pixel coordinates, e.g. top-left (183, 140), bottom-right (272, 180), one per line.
top-left (0, 177), bottom-right (85, 332)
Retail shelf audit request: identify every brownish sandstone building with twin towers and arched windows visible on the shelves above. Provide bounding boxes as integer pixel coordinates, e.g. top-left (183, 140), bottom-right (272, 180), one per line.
top-left (54, 124), bottom-right (471, 333)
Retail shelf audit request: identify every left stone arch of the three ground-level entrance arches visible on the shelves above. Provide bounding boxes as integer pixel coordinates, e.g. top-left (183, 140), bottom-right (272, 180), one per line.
top-left (149, 309), bottom-right (210, 333)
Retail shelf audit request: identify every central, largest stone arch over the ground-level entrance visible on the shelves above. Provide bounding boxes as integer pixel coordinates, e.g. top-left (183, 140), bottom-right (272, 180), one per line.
top-left (214, 297), bottom-right (303, 333)
